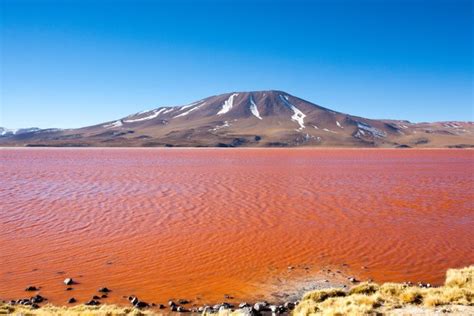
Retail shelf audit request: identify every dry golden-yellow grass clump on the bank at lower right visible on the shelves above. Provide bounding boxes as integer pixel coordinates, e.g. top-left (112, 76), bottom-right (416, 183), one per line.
top-left (293, 266), bottom-right (474, 315)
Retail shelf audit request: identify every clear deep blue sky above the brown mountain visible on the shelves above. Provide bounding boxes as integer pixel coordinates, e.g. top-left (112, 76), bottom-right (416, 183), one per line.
top-left (0, 0), bottom-right (474, 128)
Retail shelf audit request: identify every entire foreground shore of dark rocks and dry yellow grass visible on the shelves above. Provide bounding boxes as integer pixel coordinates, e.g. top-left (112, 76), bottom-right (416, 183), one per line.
top-left (0, 266), bottom-right (474, 315)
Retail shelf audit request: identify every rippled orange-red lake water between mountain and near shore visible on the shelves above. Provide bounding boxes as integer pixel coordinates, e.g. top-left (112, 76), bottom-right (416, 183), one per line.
top-left (0, 149), bottom-right (474, 304)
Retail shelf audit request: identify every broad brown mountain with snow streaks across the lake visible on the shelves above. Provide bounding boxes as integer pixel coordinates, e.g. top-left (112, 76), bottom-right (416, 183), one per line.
top-left (0, 90), bottom-right (474, 147)
